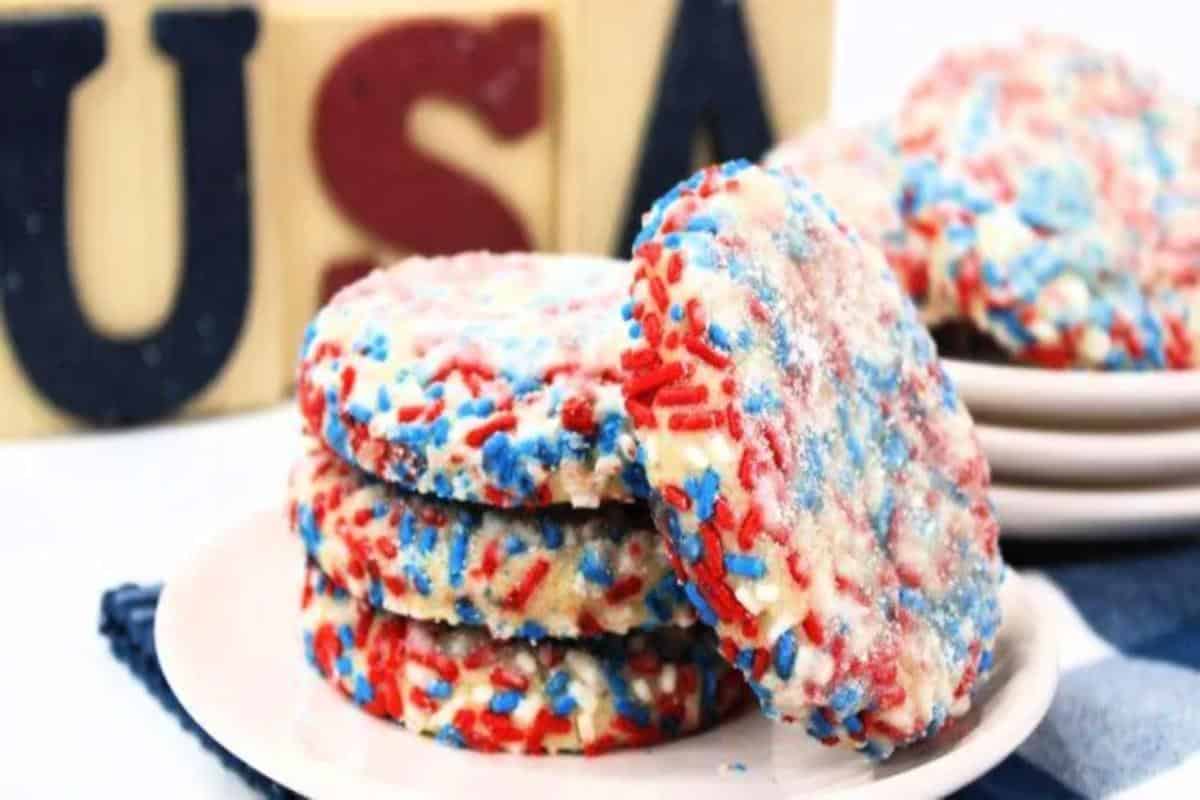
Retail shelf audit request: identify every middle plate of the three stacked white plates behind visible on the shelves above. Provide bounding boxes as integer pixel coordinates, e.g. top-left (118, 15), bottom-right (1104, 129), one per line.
top-left (976, 425), bottom-right (1200, 487)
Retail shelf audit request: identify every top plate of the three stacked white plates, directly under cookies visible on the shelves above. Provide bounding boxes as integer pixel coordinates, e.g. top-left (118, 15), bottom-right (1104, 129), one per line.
top-left (942, 359), bottom-right (1200, 429)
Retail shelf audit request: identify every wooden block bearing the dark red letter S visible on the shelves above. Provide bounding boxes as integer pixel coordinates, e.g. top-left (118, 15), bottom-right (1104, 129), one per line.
top-left (270, 0), bottom-right (557, 362)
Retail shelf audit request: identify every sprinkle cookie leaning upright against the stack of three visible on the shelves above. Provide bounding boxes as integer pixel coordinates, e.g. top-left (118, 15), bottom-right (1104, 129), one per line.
top-left (623, 162), bottom-right (1003, 757)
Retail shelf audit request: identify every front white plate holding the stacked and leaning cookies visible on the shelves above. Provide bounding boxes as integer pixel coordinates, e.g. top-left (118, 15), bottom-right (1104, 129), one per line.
top-left (156, 515), bottom-right (1057, 800)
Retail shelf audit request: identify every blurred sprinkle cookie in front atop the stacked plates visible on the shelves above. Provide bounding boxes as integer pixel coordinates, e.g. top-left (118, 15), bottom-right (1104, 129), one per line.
top-left (896, 36), bottom-right (1200, 369)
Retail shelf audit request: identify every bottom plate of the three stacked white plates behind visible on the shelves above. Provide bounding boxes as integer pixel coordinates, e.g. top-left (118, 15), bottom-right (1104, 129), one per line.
top-left (991, 483), bottom-right (1200, 540)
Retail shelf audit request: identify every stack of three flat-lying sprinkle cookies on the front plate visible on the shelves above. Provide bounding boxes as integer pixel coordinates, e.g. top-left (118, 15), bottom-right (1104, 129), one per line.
top-left (290, 253), bottom-right (746, 753)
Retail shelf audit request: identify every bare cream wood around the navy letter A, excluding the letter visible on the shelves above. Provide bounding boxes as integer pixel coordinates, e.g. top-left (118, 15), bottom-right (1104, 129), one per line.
top-left (558, 0), bottom-right (833, 253)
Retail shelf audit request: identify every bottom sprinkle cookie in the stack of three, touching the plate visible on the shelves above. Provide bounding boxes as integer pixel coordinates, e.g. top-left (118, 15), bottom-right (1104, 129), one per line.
top-left (302, 565), bottom-right (746, 754)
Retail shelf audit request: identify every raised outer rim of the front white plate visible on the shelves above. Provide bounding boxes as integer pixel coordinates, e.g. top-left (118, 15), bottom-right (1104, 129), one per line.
top-left (155, 512), bottom-right (1060, 800)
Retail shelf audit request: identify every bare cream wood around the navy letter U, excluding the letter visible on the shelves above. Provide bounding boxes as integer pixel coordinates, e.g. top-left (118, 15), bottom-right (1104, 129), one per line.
top-left (0, 0), bottom-right (290, 438)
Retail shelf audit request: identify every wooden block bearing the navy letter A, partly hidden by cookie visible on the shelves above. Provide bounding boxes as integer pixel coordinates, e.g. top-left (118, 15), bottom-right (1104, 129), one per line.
top-left (558, 0), bottom-right (833, 257)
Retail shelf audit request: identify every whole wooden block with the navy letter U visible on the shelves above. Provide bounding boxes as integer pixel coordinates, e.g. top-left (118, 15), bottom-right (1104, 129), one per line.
top-left (0, 0), bottom-right (290, 438)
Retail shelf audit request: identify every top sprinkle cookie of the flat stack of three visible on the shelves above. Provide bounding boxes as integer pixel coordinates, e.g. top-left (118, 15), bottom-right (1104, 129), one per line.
top-left (299, 253), bottom-right (644, 507)
